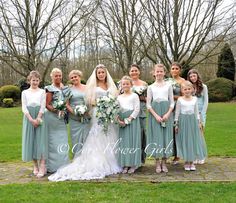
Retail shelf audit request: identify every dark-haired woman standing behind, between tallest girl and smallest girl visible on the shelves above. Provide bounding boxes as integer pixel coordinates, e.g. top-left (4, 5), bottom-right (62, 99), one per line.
top-left (170, 62), bottom-right (185, 165)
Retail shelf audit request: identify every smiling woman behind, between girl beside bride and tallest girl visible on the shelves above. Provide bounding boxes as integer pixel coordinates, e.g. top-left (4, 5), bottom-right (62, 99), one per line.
top-left (129, 64), bottom-right (148, 164)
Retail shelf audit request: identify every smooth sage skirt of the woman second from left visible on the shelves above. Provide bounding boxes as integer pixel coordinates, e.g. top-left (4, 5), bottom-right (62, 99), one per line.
top-left (45, 111), bottom-right (70, 172)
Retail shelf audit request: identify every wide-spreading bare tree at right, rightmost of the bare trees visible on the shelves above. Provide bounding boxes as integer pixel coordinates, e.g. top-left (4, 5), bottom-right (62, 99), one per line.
top-left (140, 0), bottom-right (236, 68)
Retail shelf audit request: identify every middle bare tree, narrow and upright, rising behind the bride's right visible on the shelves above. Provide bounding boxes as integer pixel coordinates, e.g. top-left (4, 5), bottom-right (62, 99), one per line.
top-left (97, 0), bottom-right (145, 73)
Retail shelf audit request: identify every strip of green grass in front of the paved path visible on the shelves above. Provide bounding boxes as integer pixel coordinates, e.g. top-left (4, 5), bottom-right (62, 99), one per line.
top-left (0, 182), bottom-right (236, 203)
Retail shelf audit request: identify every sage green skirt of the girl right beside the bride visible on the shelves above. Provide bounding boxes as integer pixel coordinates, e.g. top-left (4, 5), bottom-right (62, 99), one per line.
top-left (117, 110), bottom-right (142, 167)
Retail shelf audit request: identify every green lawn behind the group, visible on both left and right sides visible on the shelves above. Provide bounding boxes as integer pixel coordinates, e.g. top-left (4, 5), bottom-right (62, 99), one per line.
top-left (0, 103), bottom-right (236, 162)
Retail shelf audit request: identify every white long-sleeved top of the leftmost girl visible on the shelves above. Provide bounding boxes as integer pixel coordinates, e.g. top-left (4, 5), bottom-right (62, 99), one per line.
top-left (21, 89), bottom-right (46, 114)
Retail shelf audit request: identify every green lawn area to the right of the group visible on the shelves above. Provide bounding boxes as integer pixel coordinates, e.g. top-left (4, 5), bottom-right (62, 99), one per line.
top-left (205, 103), bottom-right (236, 157)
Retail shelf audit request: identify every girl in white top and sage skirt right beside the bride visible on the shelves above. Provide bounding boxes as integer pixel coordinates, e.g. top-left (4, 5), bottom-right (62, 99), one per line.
top-left (117, 76), bottom-right (141, 173)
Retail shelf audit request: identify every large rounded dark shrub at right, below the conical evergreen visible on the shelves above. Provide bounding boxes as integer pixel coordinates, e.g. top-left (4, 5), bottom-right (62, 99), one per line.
top-left (206, 78), bottom-right (234, 102)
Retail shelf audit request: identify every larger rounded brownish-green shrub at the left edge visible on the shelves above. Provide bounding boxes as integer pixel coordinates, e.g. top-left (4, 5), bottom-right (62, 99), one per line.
top-left (0, 85), bottom-right (20, 101)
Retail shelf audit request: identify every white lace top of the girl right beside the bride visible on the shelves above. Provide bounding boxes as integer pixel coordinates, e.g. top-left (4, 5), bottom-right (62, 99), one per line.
top-left (117, 93), bottom-right (140, 118)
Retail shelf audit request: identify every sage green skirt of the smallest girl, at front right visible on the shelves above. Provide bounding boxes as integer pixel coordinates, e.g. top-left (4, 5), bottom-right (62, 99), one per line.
top-left (176, 114), bottom-right (207, 162)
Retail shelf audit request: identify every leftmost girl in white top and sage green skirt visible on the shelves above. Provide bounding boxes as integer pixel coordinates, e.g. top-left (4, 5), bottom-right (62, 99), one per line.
top-left (21, 71), bottom-right (47, 178)
